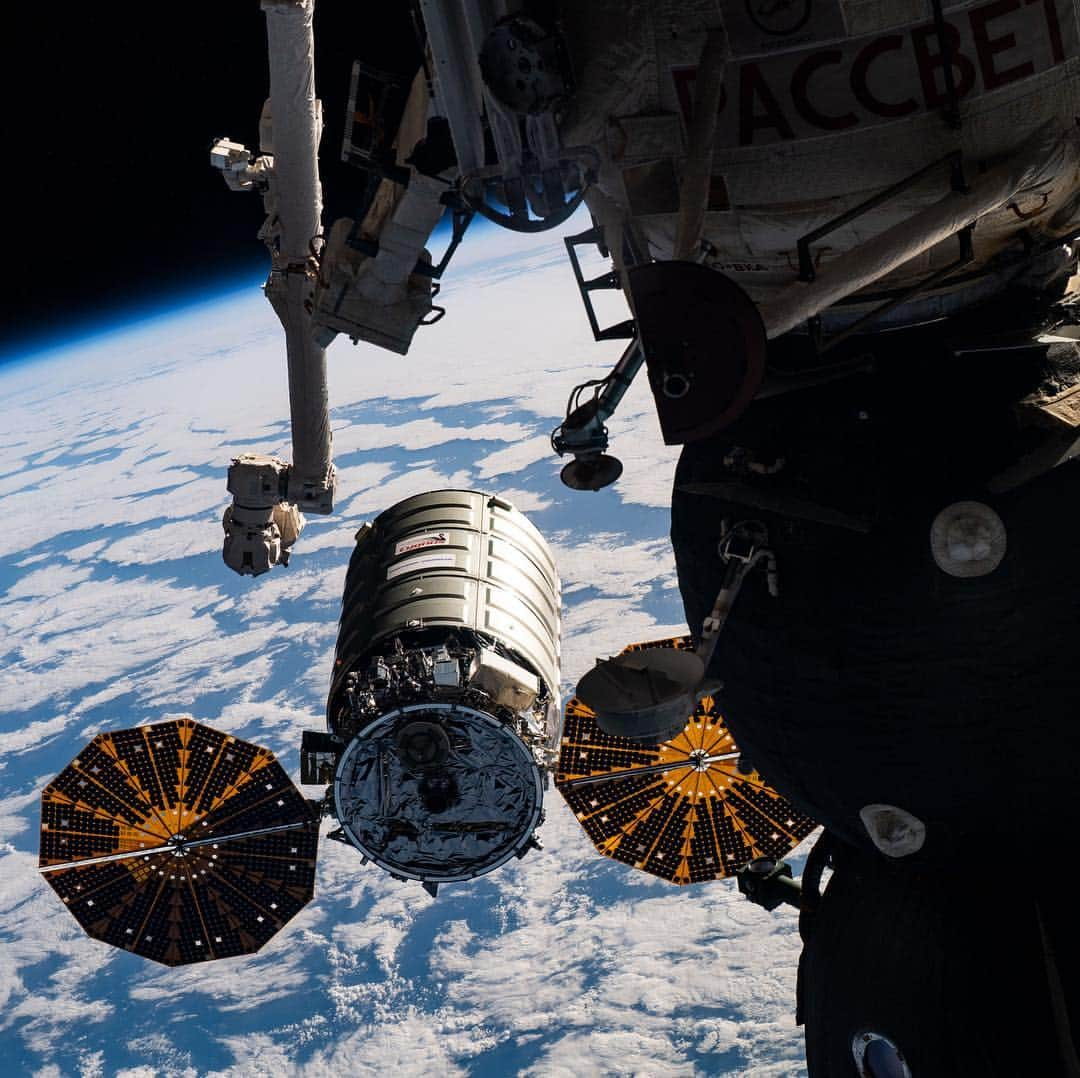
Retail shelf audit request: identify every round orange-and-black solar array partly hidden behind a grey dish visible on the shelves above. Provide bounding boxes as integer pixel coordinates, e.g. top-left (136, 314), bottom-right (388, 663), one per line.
top-left (555, 636), bottom-right (818, 885)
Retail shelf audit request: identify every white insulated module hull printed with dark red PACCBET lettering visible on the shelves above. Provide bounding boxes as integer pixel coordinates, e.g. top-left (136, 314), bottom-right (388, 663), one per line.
top-left (562, 0), bottom-right (1080, 313)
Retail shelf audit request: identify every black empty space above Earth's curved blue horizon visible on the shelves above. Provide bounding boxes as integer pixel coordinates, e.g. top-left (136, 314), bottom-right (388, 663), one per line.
top-left (0, 0), bottom-right (419, 361)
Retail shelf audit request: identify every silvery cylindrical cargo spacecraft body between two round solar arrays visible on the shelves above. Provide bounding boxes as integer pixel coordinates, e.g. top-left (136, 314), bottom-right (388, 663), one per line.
top-left (301, 490), bottom-right (561, 892)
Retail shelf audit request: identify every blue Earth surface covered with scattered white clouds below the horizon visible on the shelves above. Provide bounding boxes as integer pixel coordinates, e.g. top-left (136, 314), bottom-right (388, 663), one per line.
top-left (0, 214), bottom-right (804, 1078)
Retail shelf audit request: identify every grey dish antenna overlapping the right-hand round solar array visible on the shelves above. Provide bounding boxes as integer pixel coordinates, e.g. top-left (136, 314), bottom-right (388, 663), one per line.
top-left (576, 647), bottom-right (705, 741)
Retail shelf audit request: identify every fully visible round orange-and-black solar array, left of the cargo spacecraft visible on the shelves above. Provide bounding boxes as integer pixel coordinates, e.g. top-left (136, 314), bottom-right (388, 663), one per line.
top-left (39, 718), bottom-right (319, 966)
